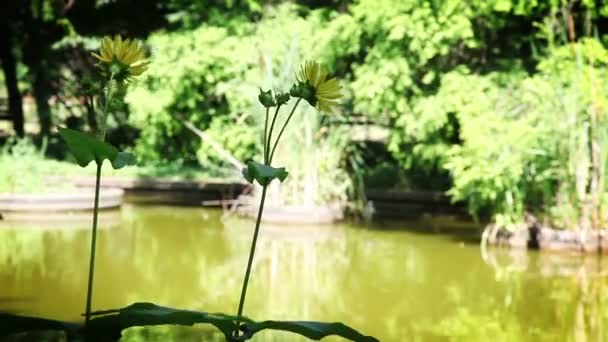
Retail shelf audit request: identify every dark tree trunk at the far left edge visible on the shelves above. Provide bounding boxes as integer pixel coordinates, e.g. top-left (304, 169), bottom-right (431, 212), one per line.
top-left (0, 16), bottom-right (25, 137)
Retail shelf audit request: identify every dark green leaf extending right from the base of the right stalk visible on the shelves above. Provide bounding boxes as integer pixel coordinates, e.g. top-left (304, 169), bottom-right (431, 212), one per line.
top-left (241, 321), bottom-right (378, 342)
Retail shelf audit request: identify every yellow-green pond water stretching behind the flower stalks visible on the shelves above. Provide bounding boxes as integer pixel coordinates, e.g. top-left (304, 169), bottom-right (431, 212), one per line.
top-left (0, 205), bottom-right (608, 341)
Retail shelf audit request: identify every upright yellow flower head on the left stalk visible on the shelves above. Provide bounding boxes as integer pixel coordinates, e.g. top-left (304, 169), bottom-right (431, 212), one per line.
top-left (93, 35), bottom-right (150, 81)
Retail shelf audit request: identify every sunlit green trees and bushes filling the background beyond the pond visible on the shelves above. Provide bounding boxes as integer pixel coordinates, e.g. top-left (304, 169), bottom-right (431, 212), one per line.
top-left (0, 0), bottom-right (608, 229)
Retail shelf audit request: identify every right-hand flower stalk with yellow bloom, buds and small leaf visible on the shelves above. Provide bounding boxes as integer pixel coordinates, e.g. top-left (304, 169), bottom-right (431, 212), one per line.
top-left (232, 62), bottom-right (342, 341)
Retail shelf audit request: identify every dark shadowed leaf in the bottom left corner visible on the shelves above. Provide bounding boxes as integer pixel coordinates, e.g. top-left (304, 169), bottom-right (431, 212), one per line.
top-left (0, 313), bottom-right (82, 340)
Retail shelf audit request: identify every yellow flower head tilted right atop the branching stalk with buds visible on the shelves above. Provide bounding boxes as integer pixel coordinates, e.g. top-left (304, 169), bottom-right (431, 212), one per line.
top-left (297, 62), bottom-right (342, 113)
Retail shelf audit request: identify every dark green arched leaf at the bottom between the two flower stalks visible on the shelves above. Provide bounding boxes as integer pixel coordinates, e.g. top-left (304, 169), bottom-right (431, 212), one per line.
top-left (87, 303), bottom-right (251, 340)
